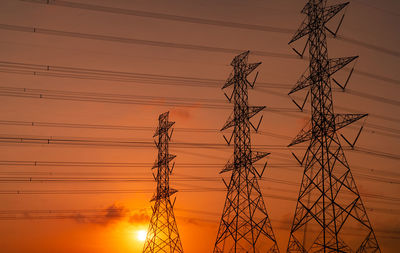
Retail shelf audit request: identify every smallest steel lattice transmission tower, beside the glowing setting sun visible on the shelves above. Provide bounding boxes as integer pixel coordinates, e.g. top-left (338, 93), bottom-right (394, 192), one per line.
top-left (143, 112), bottom-right (183, 253)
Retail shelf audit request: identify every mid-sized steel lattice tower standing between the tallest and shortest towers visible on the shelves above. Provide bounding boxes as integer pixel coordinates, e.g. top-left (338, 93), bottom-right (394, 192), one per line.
top-left (214, 51), bottom-right (279, 253)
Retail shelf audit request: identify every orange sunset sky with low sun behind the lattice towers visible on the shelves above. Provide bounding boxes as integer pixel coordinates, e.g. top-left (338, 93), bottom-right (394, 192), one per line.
top-left (0, 0), bottom-right (400, 253)
